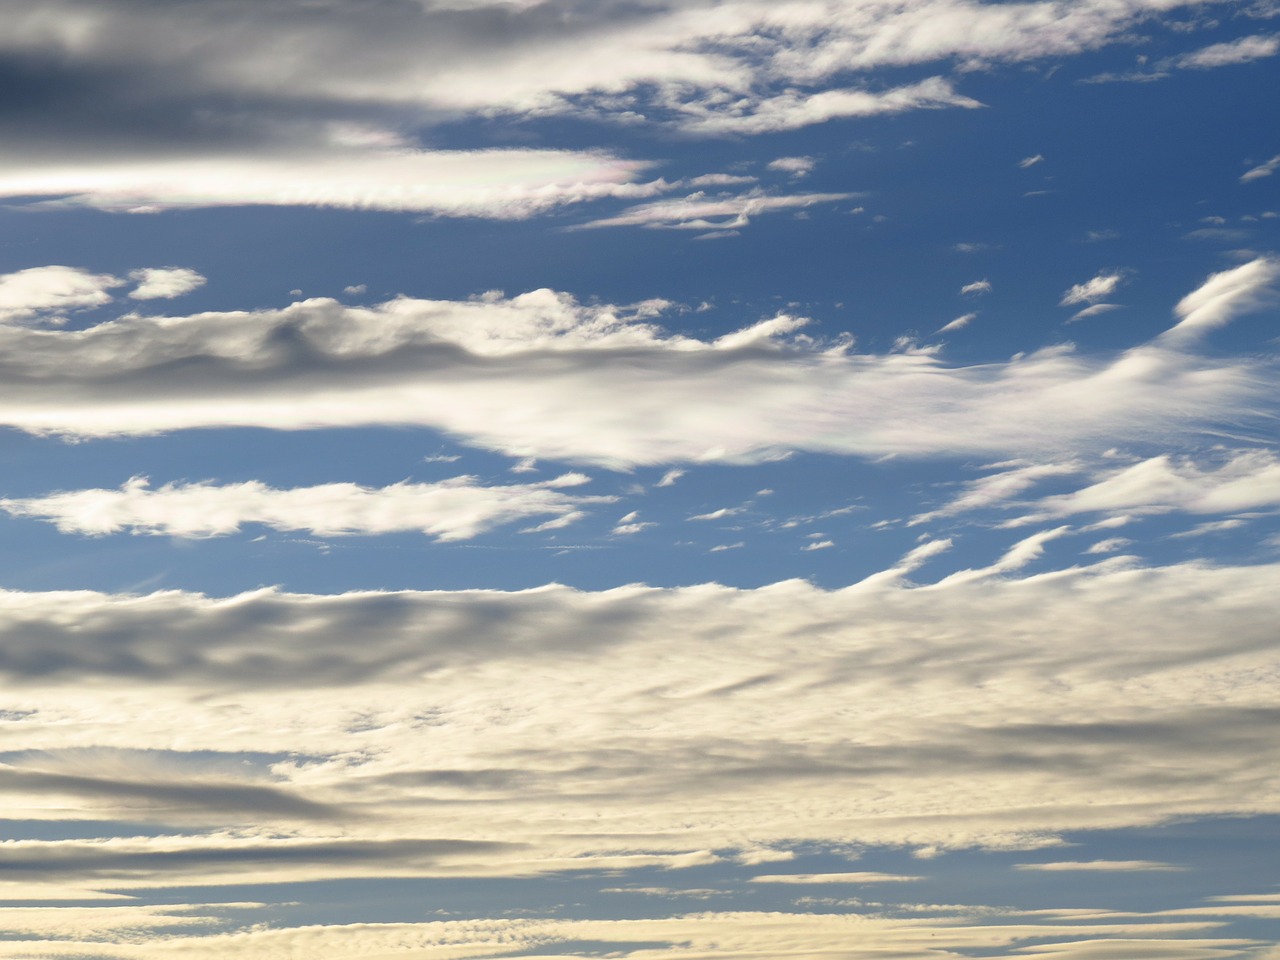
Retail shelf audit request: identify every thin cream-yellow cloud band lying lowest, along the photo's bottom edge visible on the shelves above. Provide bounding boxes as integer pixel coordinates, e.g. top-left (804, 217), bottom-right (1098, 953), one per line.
top-left (0, 908), bottom-right (1251, 960)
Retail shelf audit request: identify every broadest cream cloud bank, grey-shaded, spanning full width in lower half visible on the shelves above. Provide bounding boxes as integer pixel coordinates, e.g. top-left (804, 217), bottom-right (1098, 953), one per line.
top-left (0, 547), bottom-right (1280, 870)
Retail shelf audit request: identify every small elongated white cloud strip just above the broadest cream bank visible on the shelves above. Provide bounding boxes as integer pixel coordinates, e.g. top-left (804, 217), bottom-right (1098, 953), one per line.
top-left (0, 474), bottom-right (617, 540)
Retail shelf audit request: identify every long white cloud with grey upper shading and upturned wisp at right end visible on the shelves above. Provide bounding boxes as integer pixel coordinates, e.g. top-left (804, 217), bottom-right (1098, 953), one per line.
top-left (0, 267), bottom-right (1276, 467)
